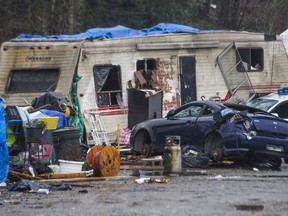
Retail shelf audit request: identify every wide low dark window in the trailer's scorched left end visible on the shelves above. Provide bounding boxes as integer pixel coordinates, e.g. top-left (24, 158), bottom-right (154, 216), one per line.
top-left (6, 69), bottom-right (60, 93)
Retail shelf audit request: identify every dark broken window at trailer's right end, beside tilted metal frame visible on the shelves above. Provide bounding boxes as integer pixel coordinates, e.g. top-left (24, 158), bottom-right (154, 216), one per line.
top-left (237, 48), bottom-right (264, 72)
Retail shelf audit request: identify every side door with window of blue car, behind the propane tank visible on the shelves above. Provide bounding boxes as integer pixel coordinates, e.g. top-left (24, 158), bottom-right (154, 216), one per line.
top-left (153, 104), bottom-right (204, 148)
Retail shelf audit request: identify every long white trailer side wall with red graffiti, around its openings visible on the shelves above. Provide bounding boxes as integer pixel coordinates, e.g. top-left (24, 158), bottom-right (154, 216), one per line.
top-left (78, 32), bottom-right (288, 142)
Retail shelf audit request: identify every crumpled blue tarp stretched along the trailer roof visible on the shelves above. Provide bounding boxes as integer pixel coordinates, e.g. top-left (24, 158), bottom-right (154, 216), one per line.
top-left (17, 23), bottom-right (214, 40)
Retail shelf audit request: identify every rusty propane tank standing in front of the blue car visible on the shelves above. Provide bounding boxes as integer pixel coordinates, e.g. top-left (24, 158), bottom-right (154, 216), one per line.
top-left (163, 136), bottom-right (182, 174)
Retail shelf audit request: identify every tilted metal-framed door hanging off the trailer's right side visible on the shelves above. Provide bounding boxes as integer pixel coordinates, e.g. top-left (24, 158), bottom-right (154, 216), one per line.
top-left (216, 43), bottom-right (255, 103)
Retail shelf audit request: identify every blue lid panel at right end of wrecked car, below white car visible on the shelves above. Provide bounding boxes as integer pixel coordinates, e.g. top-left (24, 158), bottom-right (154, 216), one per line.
top-left (251, 117), bottom-right (288, 135)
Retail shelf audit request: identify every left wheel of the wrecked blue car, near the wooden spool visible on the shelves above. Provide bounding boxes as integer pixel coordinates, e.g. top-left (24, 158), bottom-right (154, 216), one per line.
top-left (134, 131), bottom-right (151, 158)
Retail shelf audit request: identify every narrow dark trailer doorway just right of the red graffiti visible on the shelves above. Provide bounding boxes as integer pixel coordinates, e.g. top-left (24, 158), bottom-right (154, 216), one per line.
top-left (179, 56), bottom-right (196, 105)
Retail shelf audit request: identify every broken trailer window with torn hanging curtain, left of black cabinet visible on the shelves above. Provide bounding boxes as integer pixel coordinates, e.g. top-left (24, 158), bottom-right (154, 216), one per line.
top-left (93, 65), bottom-right (122, 107)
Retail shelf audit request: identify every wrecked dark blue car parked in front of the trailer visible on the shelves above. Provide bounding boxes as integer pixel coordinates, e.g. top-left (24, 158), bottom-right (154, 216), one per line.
top-left (130, 101), bottom-right (288, 167)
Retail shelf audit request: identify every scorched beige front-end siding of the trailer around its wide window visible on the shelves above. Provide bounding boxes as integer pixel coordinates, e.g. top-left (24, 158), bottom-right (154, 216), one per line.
top-left (0, 41), bottom-right (81, 106)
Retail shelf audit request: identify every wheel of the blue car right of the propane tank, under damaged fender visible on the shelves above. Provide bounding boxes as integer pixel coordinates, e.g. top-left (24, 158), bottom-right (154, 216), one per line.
top-left (204, 134), bottom-right (224, 163)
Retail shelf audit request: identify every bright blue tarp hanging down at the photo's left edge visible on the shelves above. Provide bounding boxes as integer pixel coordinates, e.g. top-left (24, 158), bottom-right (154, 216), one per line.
top-left (0, 97), bottom-right (10, 184)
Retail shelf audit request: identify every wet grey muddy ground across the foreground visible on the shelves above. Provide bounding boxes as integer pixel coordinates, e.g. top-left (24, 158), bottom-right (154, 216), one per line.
top-left (0, 164), bottom-right (288, 216)
